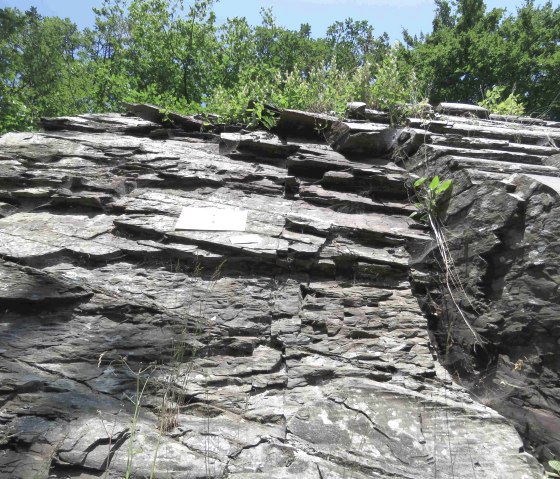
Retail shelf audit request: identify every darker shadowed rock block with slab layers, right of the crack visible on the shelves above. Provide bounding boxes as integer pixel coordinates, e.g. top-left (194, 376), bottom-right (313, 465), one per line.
top-left (405, 109), bottom-right (560, 461)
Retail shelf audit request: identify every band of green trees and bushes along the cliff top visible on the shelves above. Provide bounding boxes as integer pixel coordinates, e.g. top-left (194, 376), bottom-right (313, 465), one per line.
top-left (0, 0), bottom-right (560, 132)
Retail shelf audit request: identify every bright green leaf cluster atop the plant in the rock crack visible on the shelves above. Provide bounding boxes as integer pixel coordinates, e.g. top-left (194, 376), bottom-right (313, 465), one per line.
top-left (410, 176), bottom-right (453, 224)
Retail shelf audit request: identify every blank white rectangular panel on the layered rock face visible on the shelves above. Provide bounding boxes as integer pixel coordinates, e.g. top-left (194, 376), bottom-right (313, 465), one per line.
top-left (175, 206), bottom-right (247, 231)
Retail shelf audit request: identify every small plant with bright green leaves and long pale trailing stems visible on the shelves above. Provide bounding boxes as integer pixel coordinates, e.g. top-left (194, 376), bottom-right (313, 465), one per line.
top-left (410, 176), bottom-right (484, 347)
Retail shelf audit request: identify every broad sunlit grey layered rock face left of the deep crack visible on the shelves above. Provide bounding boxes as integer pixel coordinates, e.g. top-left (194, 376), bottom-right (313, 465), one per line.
top-left (0, 109), bottom-right (544, 479)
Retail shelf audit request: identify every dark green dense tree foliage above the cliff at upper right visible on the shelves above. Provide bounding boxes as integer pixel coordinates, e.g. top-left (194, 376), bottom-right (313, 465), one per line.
top-left (409, 0), bottom-right (560, 118)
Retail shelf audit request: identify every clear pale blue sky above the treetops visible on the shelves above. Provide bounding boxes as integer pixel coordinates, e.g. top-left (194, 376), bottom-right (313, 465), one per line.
top-left (0, 0), bottom-right (558, 40)
